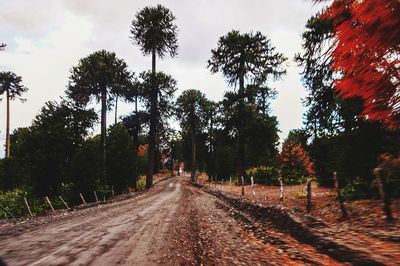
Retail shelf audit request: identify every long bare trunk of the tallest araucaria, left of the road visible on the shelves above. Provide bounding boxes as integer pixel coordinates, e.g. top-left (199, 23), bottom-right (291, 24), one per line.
top-left (146, 50), bottom-right (157, 189)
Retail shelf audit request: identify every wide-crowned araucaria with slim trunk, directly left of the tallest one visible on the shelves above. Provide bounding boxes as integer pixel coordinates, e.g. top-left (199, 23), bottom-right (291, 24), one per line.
top-left (66, 50), bottom-right (132, 183)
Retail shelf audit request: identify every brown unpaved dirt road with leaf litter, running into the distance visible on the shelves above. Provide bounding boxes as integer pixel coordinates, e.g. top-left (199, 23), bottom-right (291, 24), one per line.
top-left (0, 176), bottom-right (394, 266)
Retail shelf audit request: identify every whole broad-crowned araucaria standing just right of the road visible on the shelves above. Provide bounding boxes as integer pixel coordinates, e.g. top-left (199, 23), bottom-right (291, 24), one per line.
top-left (208, 30), bottom-right (287, 176)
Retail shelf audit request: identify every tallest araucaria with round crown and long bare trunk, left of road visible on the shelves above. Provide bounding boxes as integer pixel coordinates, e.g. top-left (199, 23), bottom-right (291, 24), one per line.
top-left (131, 5), bottom-right (178, 188)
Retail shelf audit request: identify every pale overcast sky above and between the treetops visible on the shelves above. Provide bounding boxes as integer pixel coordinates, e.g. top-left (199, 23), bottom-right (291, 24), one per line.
top-left (0, 0), bottom-right (321, 157)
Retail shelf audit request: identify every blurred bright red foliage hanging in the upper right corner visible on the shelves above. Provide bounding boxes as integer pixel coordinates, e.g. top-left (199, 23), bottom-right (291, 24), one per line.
top-left (315, 0), bottom-right (400, 128)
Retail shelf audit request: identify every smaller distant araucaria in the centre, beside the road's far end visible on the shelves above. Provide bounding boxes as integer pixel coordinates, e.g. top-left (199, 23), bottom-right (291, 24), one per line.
top-left (176, 90), bottom-right (207, 182)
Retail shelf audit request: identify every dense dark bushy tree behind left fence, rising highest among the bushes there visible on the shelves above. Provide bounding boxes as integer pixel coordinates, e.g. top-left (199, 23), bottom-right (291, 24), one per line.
top-left (27, 101), bottom-right (97, 196)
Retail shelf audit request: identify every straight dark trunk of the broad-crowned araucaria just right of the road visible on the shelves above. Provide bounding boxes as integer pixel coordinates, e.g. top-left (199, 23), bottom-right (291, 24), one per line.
top-left (238, 59), bottom-right (246, 179)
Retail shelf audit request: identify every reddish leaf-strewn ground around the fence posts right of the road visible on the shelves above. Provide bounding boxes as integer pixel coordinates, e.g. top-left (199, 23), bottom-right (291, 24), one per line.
top-left (211, 184), bottom-right (400, 265)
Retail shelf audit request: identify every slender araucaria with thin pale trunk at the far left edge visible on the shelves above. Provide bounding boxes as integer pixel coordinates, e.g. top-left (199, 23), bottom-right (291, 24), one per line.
top-left (0, 72), bottom-right (28, 158)
